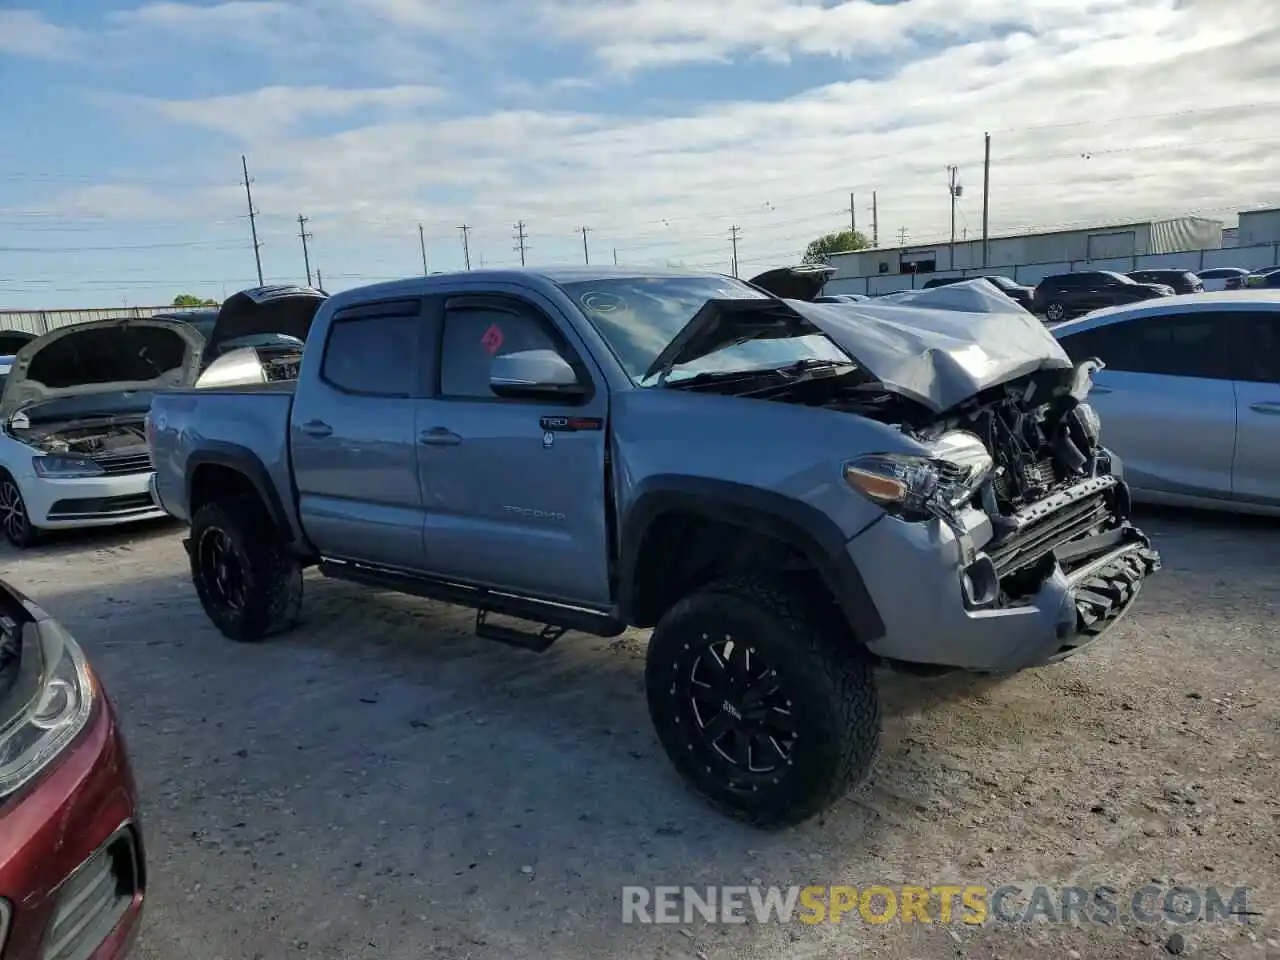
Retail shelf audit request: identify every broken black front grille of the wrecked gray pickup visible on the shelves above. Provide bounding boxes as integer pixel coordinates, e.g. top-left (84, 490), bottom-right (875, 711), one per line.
top-left (987, 476), bottom-right (1116, 579)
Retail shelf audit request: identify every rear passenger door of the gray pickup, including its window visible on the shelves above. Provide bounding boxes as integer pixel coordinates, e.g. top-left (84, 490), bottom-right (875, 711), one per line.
top-left (291, 302), bottom-right (422, 568)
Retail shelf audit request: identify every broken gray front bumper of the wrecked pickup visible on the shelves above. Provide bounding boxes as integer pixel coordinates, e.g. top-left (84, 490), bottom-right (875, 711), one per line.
top-left (849, 481), bottom-right (1160, 673)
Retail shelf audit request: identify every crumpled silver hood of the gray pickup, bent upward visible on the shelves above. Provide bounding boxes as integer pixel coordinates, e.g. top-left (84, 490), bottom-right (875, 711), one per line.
top-left (787, 291), bottom-right (1075, 413)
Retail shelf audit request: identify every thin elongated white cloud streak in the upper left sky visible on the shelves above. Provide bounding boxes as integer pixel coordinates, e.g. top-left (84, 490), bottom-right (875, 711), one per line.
top-left (128, 86), bottom-right (444, 142)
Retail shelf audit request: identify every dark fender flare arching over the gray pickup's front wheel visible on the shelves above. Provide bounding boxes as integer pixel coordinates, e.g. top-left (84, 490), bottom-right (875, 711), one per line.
top-left (617, 475), bottom-right (884, 644)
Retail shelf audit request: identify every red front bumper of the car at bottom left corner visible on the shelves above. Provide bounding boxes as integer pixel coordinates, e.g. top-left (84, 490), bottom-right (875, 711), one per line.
top-left (0, 687), bottom-right (146, 960)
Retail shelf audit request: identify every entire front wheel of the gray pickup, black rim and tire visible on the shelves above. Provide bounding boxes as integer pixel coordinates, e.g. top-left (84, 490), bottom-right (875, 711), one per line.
top-left (645, 577), bottom-right (881, 828)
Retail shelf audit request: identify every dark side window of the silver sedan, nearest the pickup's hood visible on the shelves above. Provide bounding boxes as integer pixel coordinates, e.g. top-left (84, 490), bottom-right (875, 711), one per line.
top-left (1062, 314), bottom-right (1231, 380)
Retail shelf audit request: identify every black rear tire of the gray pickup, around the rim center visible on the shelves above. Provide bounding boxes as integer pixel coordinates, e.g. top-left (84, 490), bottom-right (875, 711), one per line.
top-left (191, 498), bottom-right (302, 643)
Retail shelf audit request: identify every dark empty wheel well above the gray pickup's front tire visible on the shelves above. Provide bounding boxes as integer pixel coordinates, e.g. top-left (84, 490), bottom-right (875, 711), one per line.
top-left (628, 511), bottom-right (835, 627)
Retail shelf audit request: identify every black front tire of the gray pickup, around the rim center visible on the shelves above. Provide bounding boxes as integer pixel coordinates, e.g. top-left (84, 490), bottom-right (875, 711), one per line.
top-left (645, 577), bottom-right (881, 828)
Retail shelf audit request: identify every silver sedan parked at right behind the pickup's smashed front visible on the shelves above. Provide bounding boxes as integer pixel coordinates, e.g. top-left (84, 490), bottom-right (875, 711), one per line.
top-left (1052, 291), bottom-right (1280, 513)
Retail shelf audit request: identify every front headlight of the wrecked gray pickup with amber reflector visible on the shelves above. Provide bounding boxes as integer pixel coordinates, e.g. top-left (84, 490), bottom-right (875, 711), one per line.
top-left (844, 431), bottom-right (992, 521)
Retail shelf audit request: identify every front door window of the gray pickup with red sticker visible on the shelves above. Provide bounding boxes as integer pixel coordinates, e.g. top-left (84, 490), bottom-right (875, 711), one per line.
top-left (440, 305), bottom-right (563, 399)
